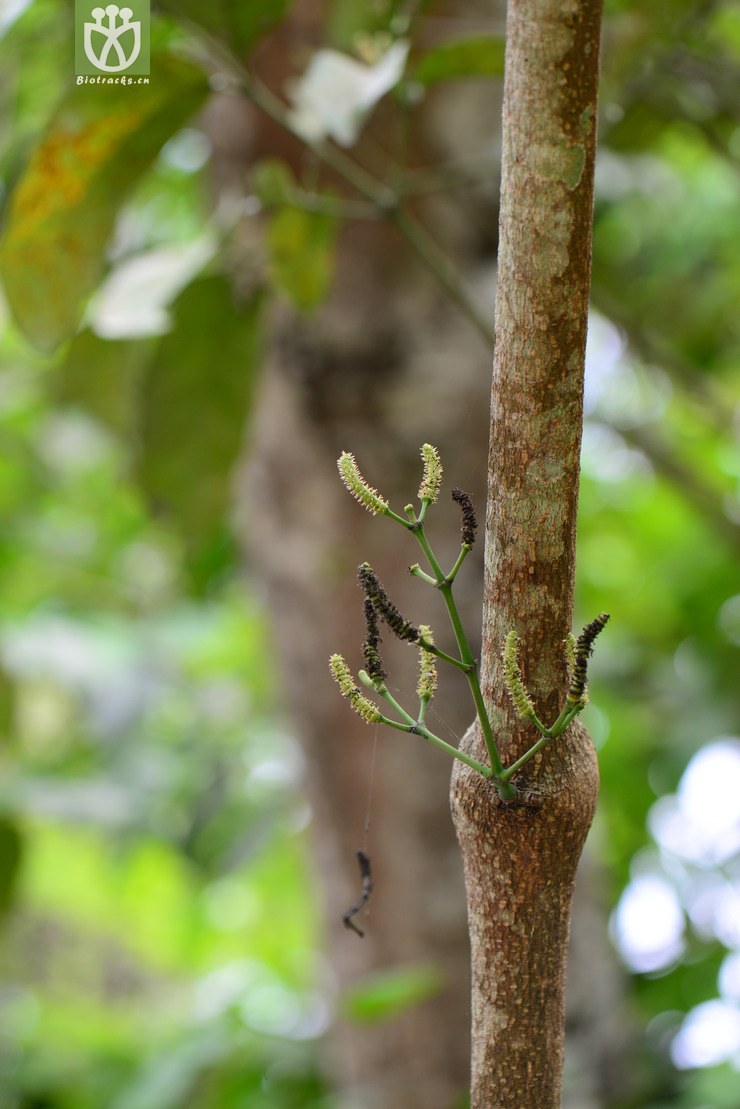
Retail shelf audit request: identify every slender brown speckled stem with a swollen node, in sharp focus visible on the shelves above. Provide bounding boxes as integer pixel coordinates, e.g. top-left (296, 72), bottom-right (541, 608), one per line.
top-left (452, 0), bottom-right (601, 1109)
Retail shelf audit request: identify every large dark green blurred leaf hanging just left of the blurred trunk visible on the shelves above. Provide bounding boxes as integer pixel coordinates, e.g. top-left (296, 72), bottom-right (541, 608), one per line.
top-left (138, 276), bottom-right (264, 584)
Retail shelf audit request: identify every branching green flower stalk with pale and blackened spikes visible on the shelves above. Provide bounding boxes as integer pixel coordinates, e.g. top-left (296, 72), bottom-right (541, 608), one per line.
top-left (330, 442), bottom-right (609, 801)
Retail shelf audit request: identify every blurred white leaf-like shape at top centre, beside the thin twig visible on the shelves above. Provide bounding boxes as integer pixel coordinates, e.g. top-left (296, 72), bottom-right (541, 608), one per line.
top-left (290, 39), bottom-right (408, 146)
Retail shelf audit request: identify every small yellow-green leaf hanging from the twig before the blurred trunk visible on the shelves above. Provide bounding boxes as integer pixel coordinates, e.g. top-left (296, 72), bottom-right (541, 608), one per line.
top-left (267, 207), bottom-right (337, 312)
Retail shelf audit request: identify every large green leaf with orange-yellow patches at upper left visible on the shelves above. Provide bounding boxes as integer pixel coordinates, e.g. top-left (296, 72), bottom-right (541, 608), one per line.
top-left (0, 57), bottom-right (207, 352)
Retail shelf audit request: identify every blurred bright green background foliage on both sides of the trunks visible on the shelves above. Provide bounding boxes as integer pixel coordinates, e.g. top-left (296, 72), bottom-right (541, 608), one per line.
top-left (0, 0), bottom-right (740, 1109)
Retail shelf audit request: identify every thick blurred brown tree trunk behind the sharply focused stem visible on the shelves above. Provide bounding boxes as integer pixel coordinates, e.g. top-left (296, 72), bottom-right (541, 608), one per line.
top-left (240, 177), bottom-right (488, 1109)
